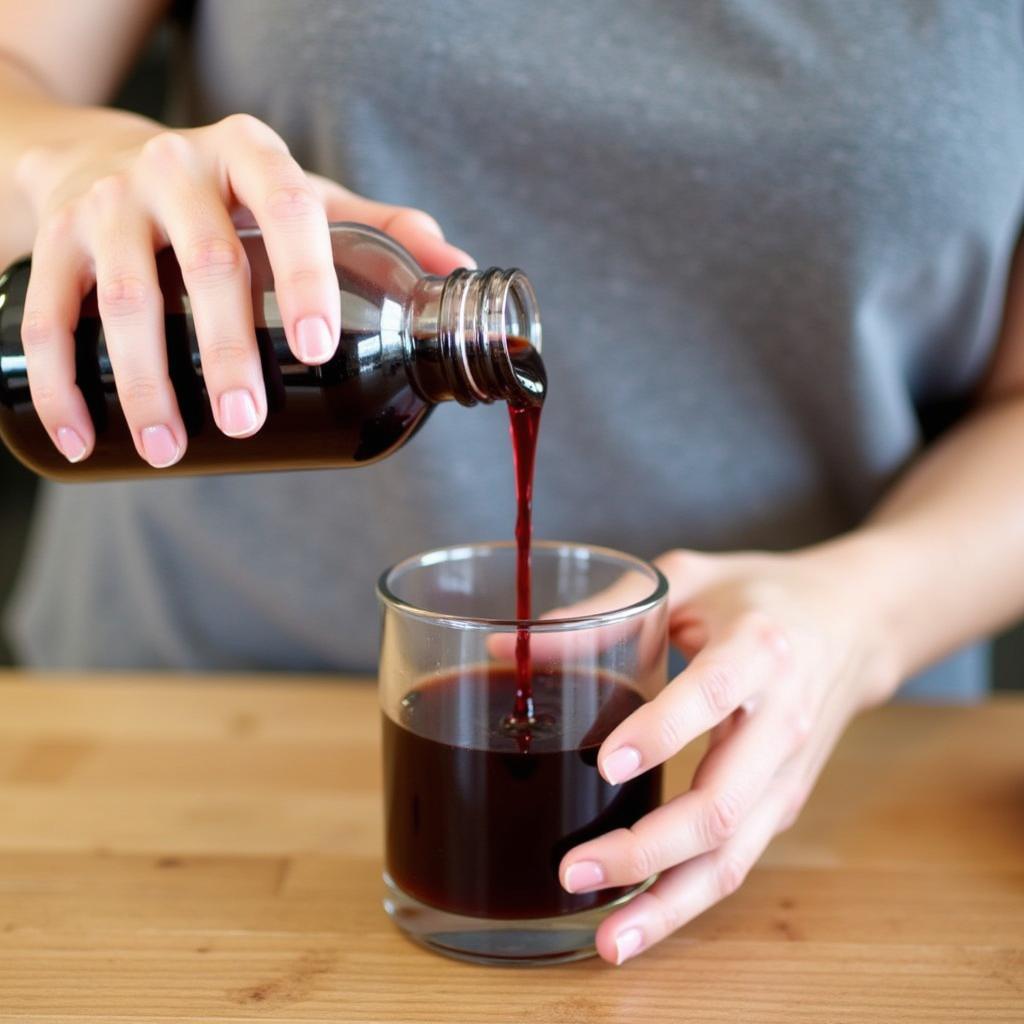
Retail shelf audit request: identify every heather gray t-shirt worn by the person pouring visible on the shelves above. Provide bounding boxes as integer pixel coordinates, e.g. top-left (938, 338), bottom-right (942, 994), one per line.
top-left (4, 0), bottom-right (1024, 694)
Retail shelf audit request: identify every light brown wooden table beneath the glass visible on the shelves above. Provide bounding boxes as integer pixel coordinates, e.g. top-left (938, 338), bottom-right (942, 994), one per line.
top-left (0, 675), bottom-right (1024, 1024)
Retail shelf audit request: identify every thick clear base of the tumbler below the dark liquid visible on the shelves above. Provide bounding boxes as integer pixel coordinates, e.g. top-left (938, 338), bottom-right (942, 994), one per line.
top-left (383, 871), bottom-right (653, 967)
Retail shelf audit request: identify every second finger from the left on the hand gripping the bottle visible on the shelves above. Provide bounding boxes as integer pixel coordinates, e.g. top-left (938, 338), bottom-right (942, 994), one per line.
top-left (90, 180), bottom-right (187, 469)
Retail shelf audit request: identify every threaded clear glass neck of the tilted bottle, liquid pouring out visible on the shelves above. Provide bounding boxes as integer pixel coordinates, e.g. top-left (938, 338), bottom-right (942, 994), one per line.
top-left (407, 268), bottom-right (547, 406)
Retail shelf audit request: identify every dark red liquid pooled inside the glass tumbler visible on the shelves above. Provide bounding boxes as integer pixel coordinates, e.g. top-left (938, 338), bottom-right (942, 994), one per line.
top-left (384, 667), bottom-right (662, 919)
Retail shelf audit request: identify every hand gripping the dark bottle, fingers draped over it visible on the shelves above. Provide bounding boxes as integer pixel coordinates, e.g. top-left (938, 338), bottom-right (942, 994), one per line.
top-left (15, 111), bottom-right (472, 468)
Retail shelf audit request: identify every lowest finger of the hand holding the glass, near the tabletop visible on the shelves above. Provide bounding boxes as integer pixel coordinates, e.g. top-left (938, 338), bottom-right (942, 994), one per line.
top-left (595, 788), bottom-right (785, 965)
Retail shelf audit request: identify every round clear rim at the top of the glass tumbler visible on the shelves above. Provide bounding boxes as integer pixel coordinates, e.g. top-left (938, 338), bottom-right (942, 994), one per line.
top-left (377, 541), bottom-right (669, 633)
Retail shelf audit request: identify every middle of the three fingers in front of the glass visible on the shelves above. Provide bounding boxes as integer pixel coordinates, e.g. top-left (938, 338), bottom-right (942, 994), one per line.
top-left (559, 701), bottom-right (809, 892)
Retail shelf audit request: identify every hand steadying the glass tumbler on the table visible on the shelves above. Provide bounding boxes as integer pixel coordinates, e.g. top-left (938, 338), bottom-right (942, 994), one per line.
top-left (559, 548), bottom-right (898, 964)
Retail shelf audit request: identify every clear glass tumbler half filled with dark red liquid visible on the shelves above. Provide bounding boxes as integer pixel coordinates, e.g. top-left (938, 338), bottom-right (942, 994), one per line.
top-left (378, 542), bottom-right (668, 965)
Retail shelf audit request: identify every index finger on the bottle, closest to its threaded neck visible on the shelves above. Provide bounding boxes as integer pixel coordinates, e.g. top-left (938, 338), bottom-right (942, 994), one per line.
top-left (218, 118), bottom-right (341, 366)
